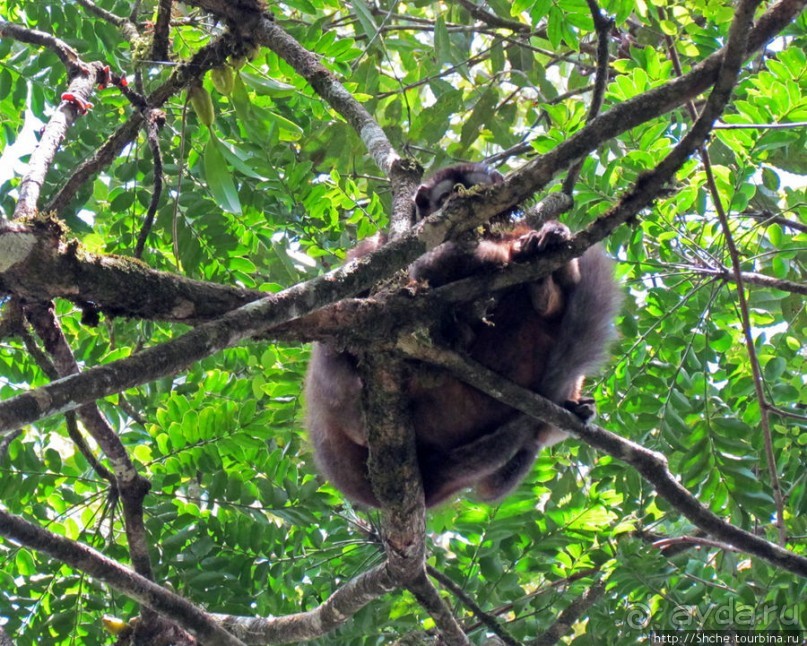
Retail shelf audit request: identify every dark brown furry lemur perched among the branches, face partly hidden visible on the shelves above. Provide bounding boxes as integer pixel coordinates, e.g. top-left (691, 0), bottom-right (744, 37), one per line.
top-left (306, 164), bottom-right (620, 506)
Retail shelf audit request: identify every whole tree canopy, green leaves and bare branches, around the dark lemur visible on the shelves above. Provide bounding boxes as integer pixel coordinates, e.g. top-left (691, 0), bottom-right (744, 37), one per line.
top-left (0, 0), bottom-right (807, 646)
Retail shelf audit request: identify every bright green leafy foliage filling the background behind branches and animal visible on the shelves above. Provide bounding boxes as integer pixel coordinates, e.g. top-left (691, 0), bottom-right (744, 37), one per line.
top-left (0, 0), bottom-right (807, 644)
